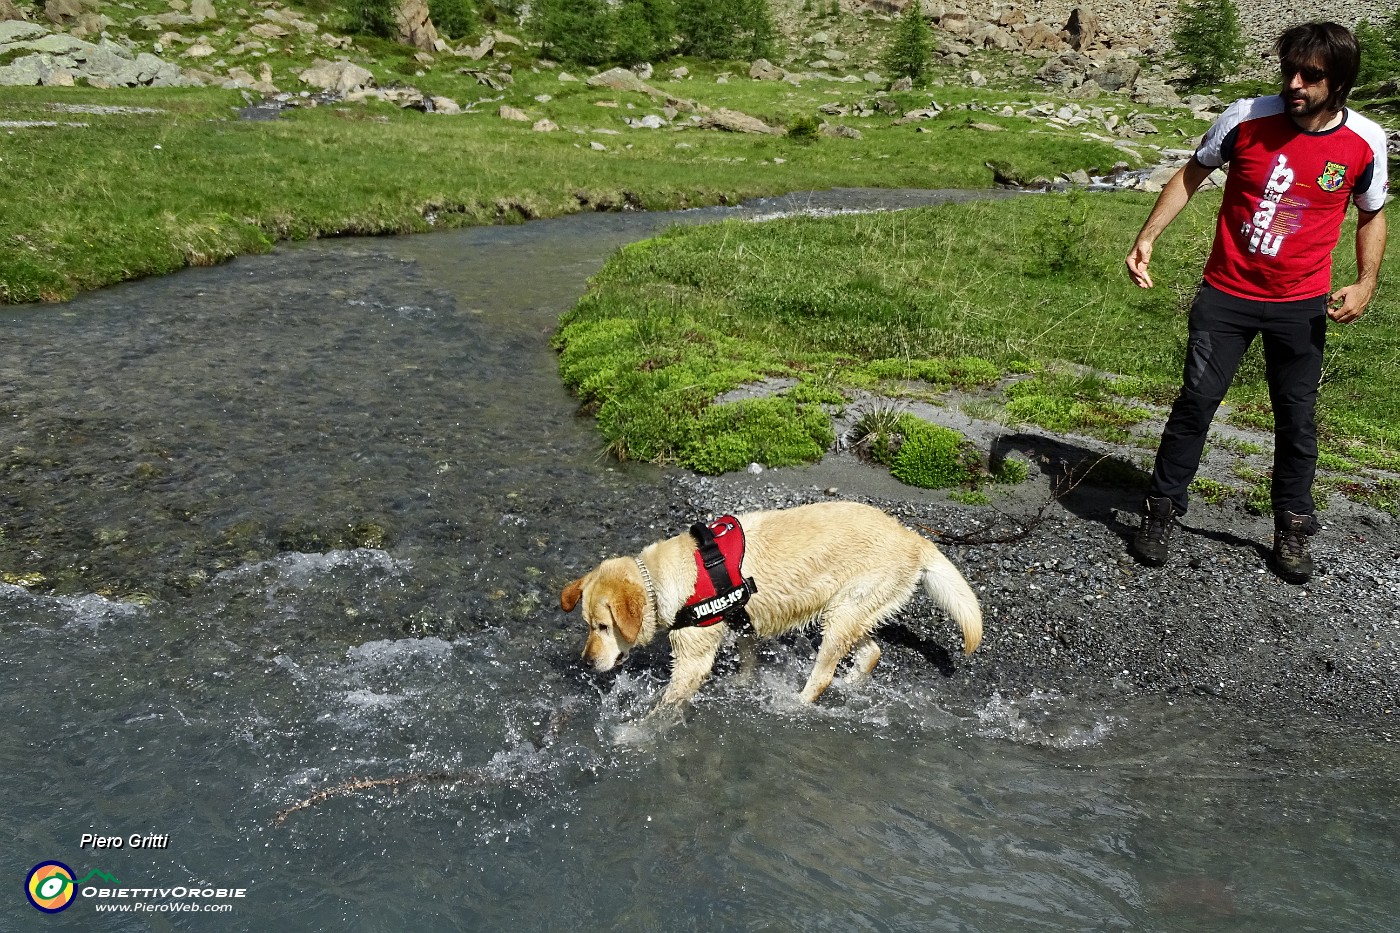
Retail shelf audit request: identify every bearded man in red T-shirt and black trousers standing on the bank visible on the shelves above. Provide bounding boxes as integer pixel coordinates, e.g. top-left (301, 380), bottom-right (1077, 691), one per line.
top-left (1127, 22), bottom-right (1386, 583)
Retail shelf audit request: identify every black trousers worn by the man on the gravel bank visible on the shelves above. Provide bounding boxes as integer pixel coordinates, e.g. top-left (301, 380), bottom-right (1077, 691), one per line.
top-left (1152, 283), bottom-right (1327, 516)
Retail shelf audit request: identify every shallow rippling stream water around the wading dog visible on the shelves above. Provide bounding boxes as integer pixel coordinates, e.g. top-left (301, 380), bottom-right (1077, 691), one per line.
top-left (0, 193), bottom-right (1400, 932)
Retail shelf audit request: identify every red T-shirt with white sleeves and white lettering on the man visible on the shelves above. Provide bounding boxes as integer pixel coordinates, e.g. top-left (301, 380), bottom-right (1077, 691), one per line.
top-left (1196, 94), bottom-right (1387, 301)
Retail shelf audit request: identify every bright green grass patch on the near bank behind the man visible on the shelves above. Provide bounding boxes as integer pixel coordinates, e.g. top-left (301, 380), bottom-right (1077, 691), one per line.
top-left (556, 193), bottom-right (1400, 509)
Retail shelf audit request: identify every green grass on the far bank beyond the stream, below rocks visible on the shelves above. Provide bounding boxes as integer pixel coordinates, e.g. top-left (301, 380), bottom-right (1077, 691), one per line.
top-left (0, 0), bottom-right (1204, 303)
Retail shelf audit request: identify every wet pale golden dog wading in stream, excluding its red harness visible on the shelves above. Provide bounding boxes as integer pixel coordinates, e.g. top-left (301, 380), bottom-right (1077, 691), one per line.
top-left (559, 502), bottom-right (981, 712)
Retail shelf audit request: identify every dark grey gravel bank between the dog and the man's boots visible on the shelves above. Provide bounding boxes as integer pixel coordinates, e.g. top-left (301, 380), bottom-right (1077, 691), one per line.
top-left (671, 458), bottom-right (1400, 740)
